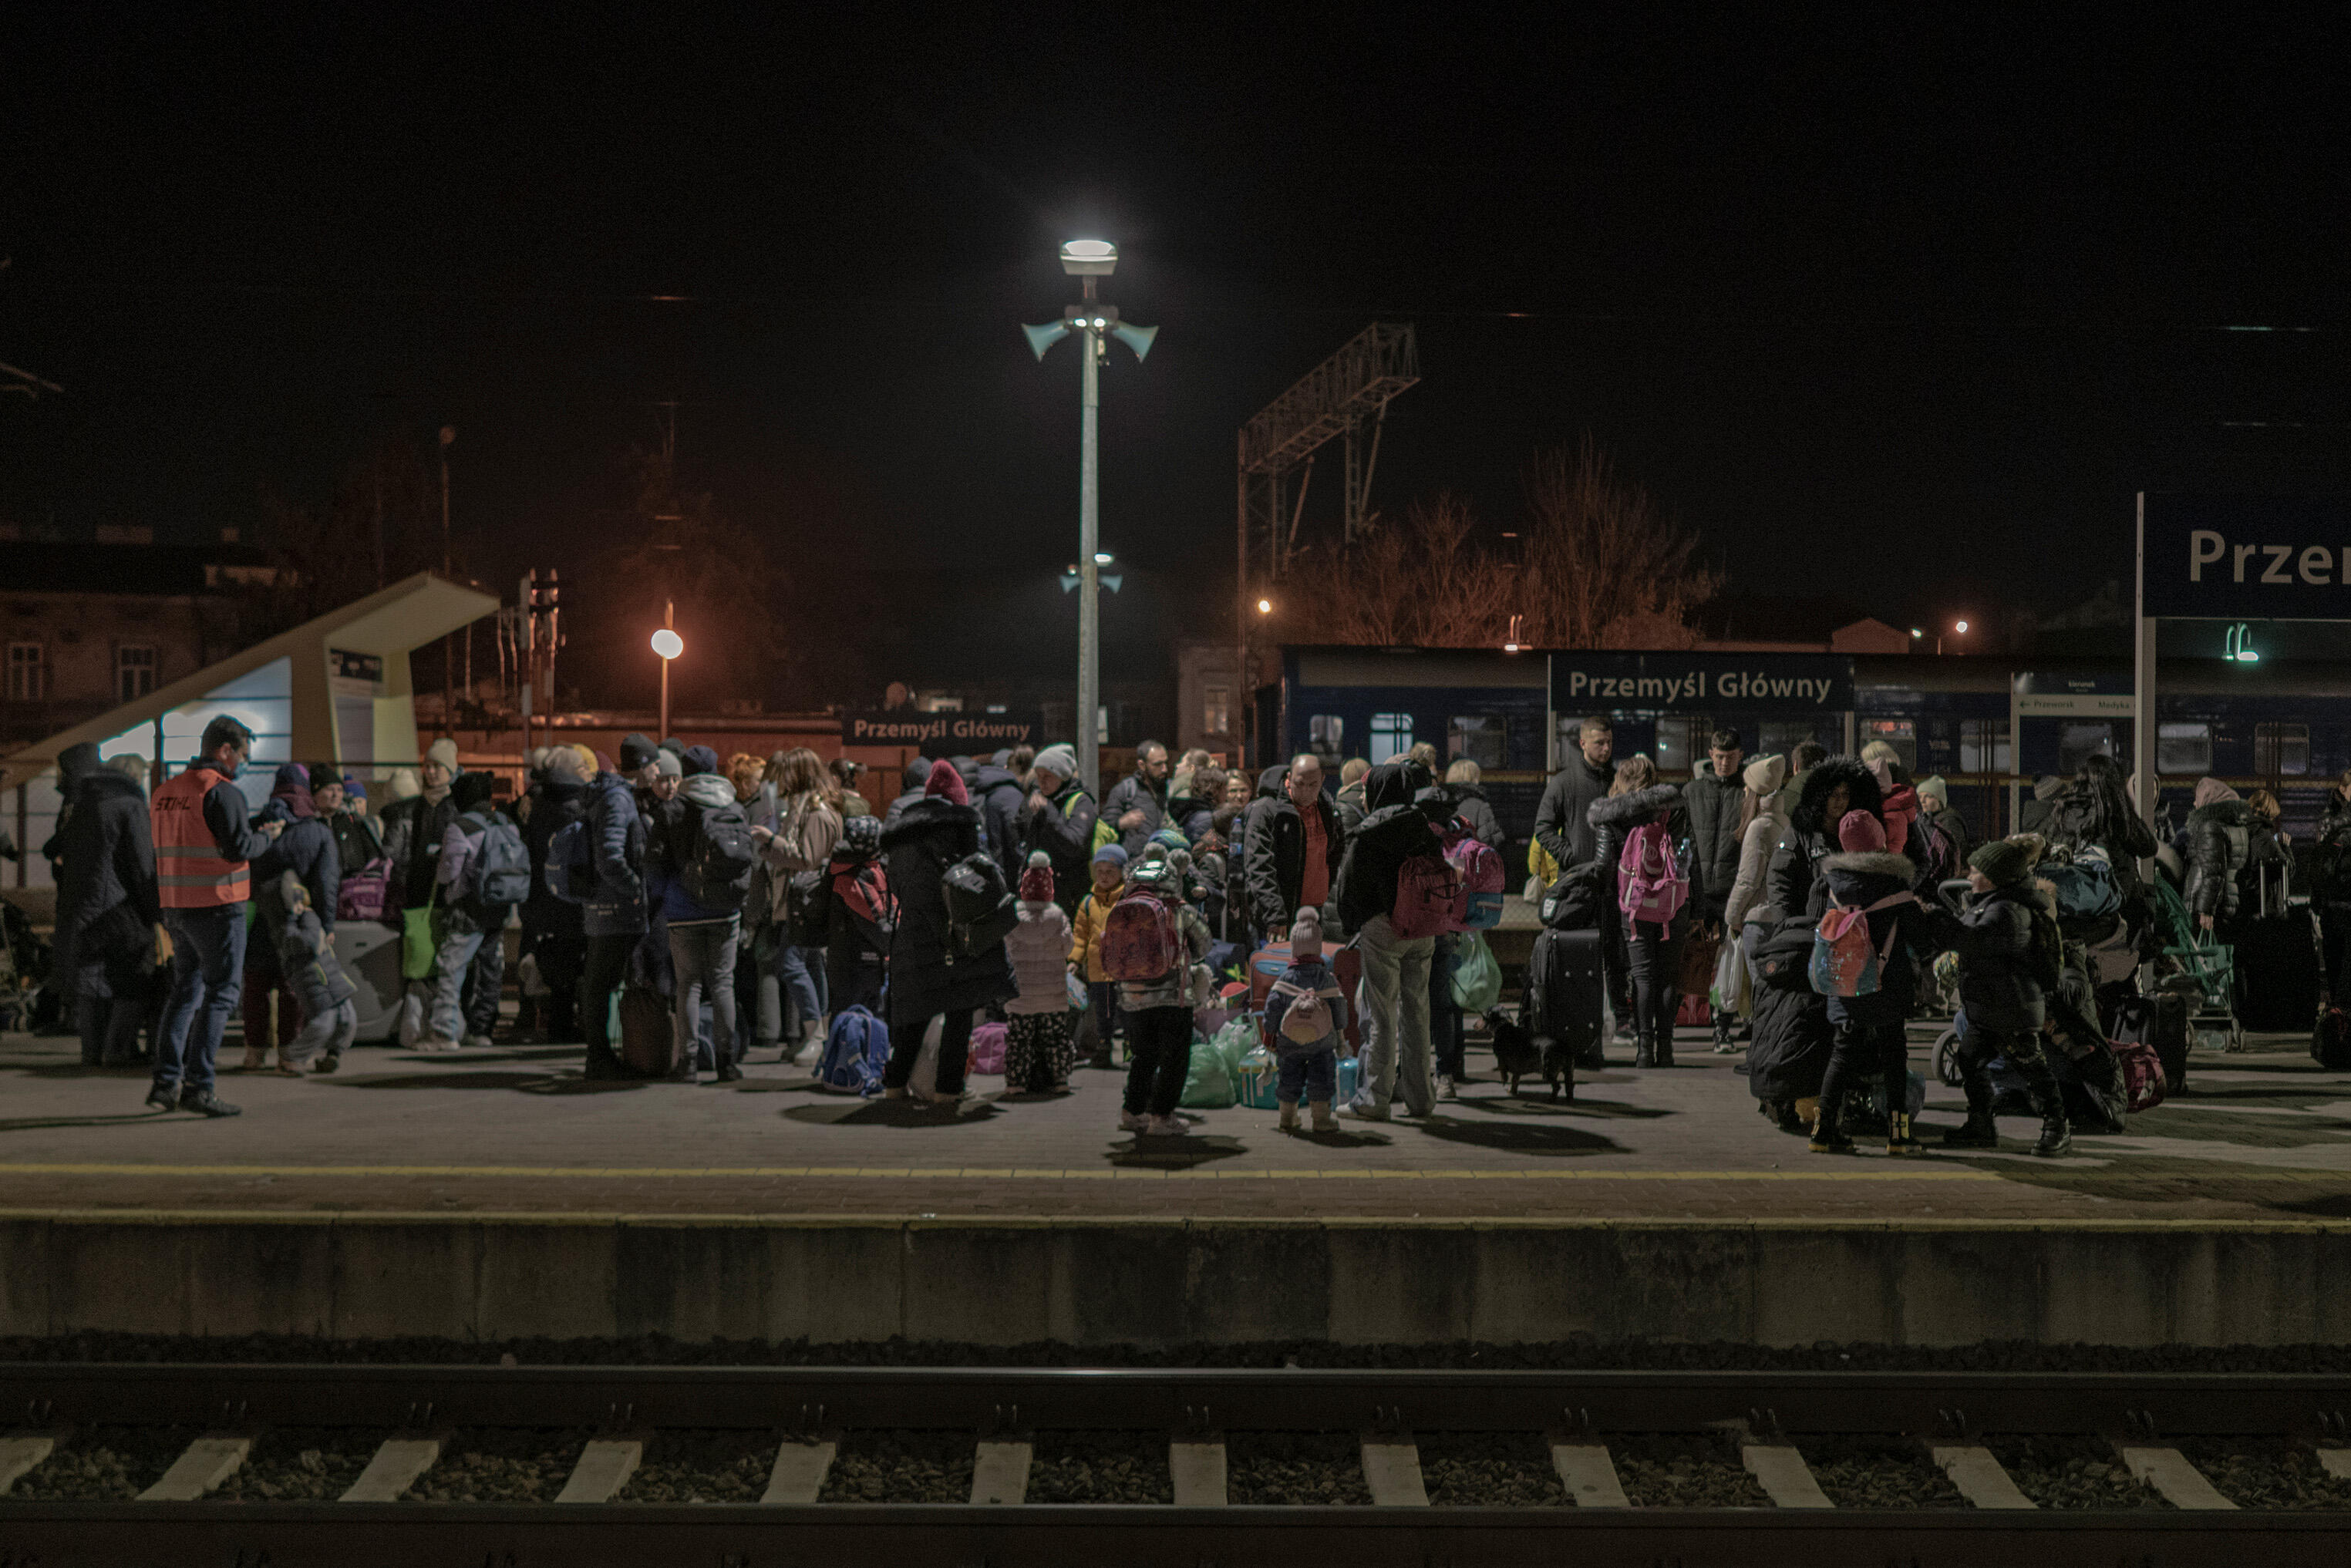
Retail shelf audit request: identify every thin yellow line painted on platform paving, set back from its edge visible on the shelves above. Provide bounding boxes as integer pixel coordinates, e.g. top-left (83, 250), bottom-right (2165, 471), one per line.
top-left (0, 1161), bottom-right (2003, 1183)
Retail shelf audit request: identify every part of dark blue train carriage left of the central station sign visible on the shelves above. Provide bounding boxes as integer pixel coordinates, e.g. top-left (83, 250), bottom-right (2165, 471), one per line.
top-left (1279, 647), bottom-right (1549, 884)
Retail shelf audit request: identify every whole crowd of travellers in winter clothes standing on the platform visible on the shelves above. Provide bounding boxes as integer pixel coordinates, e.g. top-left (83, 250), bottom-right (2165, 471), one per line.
top-left (47, 717), bottom-right (2351, 1152)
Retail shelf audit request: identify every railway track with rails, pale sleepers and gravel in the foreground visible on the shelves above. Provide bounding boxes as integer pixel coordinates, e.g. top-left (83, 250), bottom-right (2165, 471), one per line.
top-left (0, 1364), bottom-right (2351, 1568)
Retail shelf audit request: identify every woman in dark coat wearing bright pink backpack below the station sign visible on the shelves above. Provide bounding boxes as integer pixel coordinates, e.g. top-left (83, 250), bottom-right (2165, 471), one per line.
top-left (1585, 755), bottom-right (1705, 1067)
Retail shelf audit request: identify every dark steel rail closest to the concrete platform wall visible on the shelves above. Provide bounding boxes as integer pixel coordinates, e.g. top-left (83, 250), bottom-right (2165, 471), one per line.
top-left (13, 1364), bottom-right (2351, 1438)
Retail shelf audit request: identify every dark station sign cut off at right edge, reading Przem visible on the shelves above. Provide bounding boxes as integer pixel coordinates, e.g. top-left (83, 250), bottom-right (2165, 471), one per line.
top-left (2142, 493), bottom-right (2351, 621)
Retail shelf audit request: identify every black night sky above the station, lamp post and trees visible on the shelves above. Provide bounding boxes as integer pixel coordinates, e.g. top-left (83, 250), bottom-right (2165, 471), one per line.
top-left (0, 7), bottom-right (2351, 653)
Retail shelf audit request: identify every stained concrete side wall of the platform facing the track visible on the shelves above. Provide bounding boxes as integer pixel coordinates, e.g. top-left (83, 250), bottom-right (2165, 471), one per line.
top-left (0, 1208), bottom-right (2351, 1347)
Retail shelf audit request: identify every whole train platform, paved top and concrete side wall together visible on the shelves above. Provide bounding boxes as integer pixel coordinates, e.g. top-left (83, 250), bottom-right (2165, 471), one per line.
top-left (0, 1032), bottom-right (2351, 1342)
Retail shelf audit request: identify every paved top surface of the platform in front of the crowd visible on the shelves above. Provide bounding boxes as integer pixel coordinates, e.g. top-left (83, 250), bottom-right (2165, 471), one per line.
top-left (0, 1030), bottom-right (2351, 1225)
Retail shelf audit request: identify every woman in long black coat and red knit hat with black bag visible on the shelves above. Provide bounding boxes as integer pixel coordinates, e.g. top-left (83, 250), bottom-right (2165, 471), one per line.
top-left (881, 762), bottom-right (1013, 1100)
